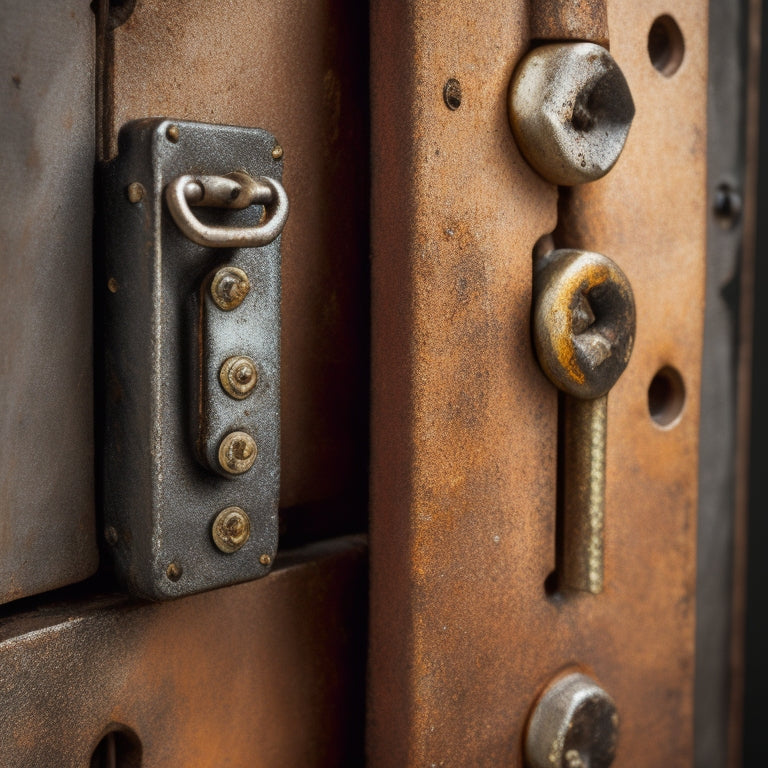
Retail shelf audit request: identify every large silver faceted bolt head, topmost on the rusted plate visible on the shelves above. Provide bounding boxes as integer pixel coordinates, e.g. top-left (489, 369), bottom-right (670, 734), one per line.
top-left (508, 43), bottom-right (635, 186)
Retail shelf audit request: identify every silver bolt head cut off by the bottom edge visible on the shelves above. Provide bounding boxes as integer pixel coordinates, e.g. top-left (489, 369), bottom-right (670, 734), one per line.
top-left (525, 673), bottom-right (619, 768)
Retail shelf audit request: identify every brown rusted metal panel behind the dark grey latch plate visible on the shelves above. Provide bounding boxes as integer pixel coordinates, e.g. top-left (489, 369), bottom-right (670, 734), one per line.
top-left (99, 0), bottom-right (368, 525)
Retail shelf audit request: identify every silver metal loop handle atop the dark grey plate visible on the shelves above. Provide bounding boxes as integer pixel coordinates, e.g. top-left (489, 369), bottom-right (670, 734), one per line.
top-left (165, 173), bottom-right (288, 248)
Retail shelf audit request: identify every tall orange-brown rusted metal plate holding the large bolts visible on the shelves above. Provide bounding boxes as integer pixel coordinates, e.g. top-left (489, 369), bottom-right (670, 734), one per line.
top-left (368, 0), bottom-right (707, 768)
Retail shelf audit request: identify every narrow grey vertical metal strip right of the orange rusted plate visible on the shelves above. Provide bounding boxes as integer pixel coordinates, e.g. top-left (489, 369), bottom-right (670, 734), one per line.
top-left (694, 0), bottom-right (759, 768)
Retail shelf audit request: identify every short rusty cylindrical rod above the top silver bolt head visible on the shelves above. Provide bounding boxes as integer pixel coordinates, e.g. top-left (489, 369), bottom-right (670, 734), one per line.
top-left (529, 0), bottom-right (613, 48)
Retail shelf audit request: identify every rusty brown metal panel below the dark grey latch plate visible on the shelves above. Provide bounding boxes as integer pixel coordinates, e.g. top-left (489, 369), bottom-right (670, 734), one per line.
top-left (0, 538), bottom-right (366, 768)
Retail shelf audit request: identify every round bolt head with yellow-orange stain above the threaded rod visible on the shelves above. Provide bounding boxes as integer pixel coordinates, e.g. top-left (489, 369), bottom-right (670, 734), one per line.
top-left (533, 249), bottom-right (635, 400)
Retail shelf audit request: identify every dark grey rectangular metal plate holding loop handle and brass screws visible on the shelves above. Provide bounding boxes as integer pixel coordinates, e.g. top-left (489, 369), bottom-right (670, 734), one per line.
top-left (98, 118), bottom-right (282, 599)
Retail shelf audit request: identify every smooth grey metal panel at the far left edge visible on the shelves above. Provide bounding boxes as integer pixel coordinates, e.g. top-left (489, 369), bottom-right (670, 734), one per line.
top-left (0, 0), bottom-right (97, 602)
